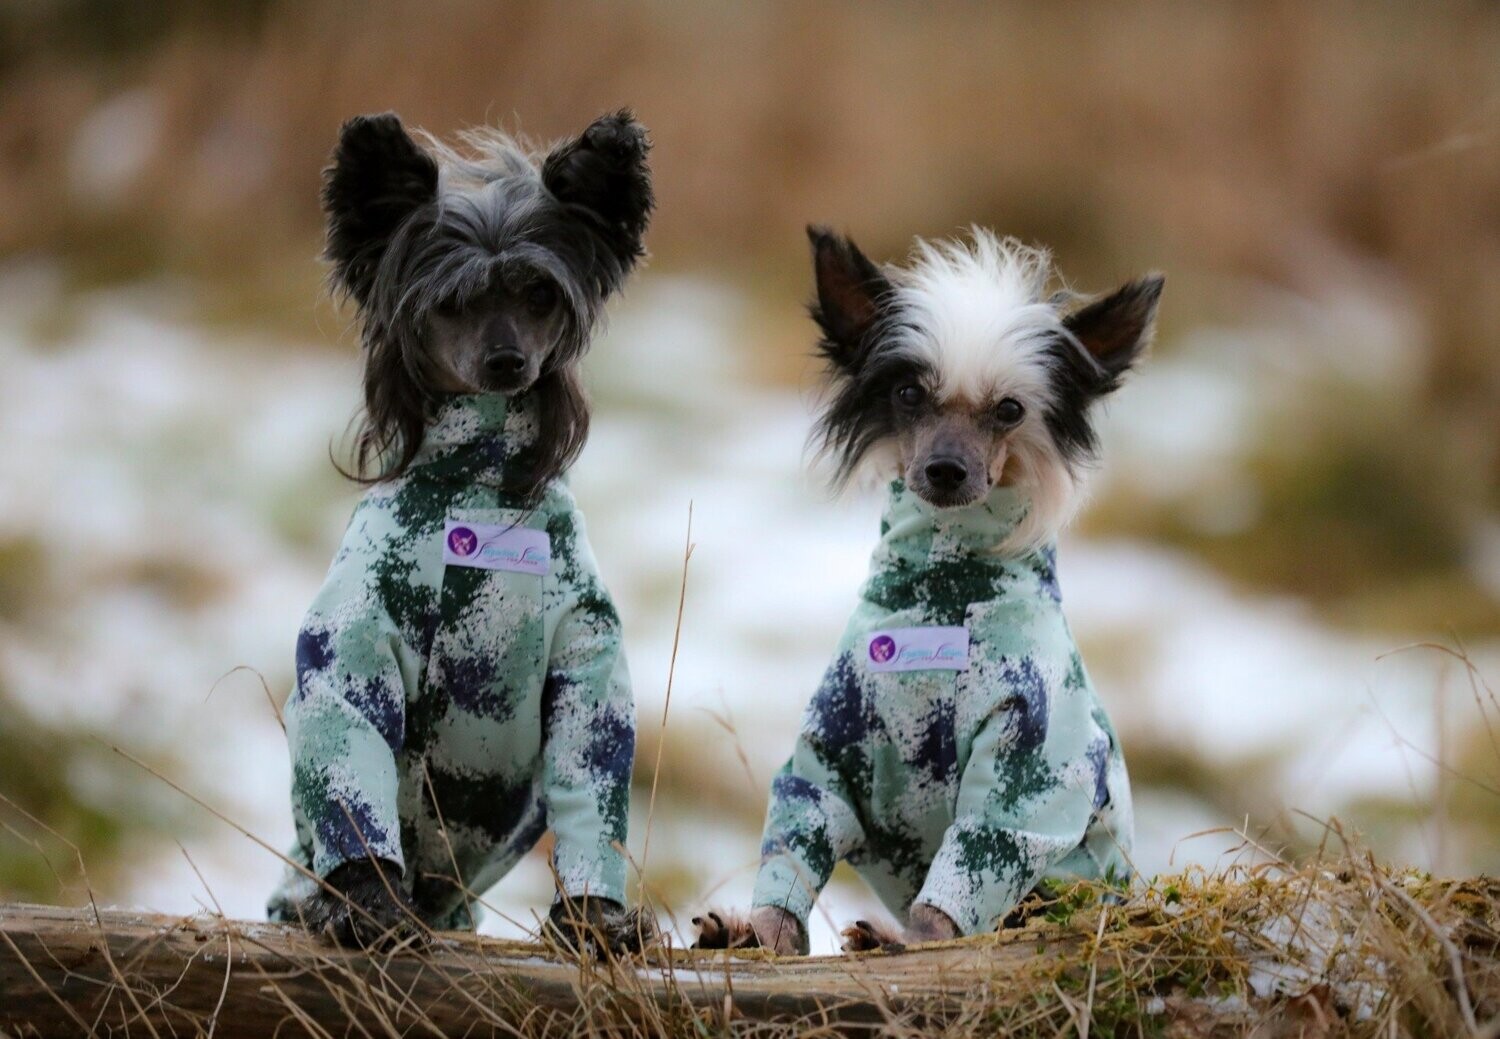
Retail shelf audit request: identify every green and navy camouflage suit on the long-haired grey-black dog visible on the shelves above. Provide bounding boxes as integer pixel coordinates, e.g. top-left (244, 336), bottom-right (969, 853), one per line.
top-left (270, 394), bottom-right (635, 928)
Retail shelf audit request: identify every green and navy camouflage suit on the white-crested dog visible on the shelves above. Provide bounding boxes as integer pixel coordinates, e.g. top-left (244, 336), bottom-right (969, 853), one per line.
top-left (755, 481), bottom-right (1131, 934)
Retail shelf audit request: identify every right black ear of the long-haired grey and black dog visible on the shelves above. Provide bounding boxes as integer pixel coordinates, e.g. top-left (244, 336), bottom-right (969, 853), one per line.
top-left (542, 108), bottom-right (656, 287)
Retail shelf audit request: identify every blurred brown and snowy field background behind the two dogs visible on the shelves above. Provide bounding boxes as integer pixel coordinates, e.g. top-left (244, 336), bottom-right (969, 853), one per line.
top-left (0, 0), bottom-right (1500, 949)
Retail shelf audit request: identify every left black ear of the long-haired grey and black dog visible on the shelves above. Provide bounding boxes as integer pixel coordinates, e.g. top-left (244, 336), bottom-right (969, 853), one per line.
top-left (323, 112), bottom-right (438, 304)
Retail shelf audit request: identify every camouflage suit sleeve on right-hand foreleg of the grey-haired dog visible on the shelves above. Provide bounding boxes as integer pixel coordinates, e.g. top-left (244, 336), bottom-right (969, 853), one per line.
top-left (542, 513), bottom-right (636, 904)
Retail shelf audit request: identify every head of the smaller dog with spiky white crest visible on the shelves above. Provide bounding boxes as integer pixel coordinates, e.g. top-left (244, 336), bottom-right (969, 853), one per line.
top-left (809, 228), bottom-right (1163, 550)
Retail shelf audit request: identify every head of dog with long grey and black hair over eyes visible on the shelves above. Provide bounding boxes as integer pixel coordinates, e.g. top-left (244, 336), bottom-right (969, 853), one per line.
top-left (323, 111), bottom-right (653, 493)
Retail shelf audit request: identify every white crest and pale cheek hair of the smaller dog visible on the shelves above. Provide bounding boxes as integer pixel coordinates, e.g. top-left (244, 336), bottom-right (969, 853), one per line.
top-left (876, 226), bottom-right (1083, 555)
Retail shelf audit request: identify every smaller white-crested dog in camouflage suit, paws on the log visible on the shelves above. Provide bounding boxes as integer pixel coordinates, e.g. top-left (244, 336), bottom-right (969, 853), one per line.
top-left (698, 228), bottom-right (1163, 954)
